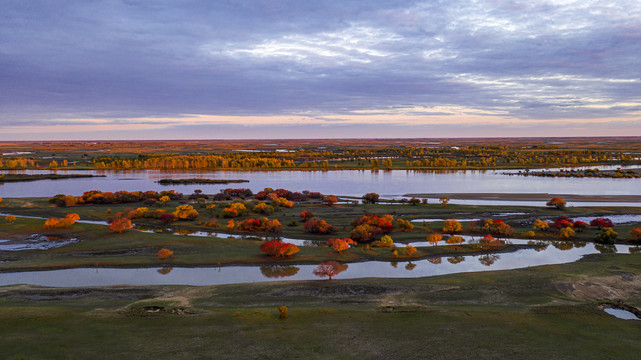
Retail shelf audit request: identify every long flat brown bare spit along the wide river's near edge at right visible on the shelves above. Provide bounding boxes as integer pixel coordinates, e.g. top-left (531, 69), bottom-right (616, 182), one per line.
top-left (403, 193), bottom-right (641, 202)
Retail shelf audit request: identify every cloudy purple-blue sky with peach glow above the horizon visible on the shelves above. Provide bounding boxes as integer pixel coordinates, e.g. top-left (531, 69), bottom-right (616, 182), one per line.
top-left (0, 0), bottom-right (641, 140)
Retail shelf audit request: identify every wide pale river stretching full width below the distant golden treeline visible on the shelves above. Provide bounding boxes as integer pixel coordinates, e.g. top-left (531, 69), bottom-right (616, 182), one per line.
top-left (0, 167), bottom-right (641, 206)
